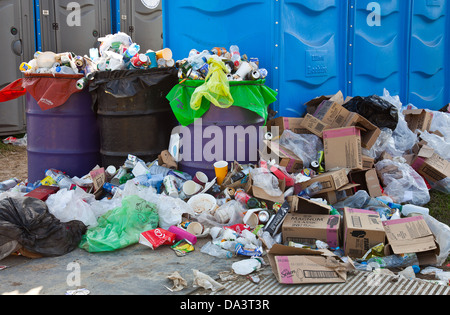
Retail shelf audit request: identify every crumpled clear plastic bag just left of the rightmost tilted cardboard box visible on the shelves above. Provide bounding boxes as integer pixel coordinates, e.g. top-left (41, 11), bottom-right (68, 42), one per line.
top-left (375, 159), bottom-right (430, 206)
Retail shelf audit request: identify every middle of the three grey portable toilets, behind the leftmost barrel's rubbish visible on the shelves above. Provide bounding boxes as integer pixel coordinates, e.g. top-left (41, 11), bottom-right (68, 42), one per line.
top-left (39, 0), bottom-right (112, 55)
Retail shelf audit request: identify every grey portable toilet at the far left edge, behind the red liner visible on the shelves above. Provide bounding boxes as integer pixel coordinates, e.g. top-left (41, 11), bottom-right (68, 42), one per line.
top-left (0, 0), bottom-right (35, 136)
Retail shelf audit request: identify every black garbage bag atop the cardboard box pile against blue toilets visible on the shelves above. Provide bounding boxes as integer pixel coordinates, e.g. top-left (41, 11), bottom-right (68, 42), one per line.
top-left (344, 95), bottom-right (399, 131)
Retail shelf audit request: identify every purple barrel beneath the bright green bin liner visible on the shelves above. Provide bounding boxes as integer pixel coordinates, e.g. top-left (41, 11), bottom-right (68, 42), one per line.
top-left (178, 104), bottom-right (265, 180)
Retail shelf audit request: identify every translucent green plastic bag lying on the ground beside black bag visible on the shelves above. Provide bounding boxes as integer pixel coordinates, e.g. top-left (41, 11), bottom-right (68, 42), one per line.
top-left (79, 196), bottom-right (159, 253)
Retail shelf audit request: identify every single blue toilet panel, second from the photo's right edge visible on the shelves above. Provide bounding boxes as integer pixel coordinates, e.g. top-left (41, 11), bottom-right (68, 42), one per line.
top-left (347, 0), bottom-right (410, 100)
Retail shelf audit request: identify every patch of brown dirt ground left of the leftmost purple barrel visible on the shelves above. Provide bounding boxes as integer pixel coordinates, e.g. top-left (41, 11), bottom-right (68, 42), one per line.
top-left (0, 147), bottom-right (28, 181)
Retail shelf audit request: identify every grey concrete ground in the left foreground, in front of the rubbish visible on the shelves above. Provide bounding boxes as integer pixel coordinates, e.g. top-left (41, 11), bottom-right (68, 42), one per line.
top-left (0, 239), bottom-right (242, 296)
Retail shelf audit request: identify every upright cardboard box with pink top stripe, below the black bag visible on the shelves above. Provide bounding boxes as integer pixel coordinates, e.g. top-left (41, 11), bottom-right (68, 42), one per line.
top-left (323, 127), bottom-right (363, 171)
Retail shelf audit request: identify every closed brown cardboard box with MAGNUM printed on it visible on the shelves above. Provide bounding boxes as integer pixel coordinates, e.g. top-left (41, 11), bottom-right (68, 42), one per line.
top-left (282, 213), bottom-right (341, 248)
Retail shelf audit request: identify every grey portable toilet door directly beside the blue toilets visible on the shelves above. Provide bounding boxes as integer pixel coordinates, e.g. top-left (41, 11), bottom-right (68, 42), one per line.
top-left (120, 0), bottom-right (163, 51)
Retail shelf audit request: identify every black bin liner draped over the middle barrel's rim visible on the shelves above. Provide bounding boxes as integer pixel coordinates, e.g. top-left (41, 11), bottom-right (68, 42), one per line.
top-left (89, 68), bottom-right (178, 100)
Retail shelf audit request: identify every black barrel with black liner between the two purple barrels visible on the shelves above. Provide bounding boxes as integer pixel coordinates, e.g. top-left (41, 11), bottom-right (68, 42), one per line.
top-left (89, 68), bottom-right (178, 168)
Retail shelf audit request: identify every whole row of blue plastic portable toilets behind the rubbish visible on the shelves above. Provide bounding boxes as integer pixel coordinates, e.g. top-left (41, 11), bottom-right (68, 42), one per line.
top-left (163, 0), bottom-right (450, 117)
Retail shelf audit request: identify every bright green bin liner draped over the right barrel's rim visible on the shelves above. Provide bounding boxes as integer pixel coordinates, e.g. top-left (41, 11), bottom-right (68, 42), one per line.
top-left (167, 80), bottom-right (278, 127)
